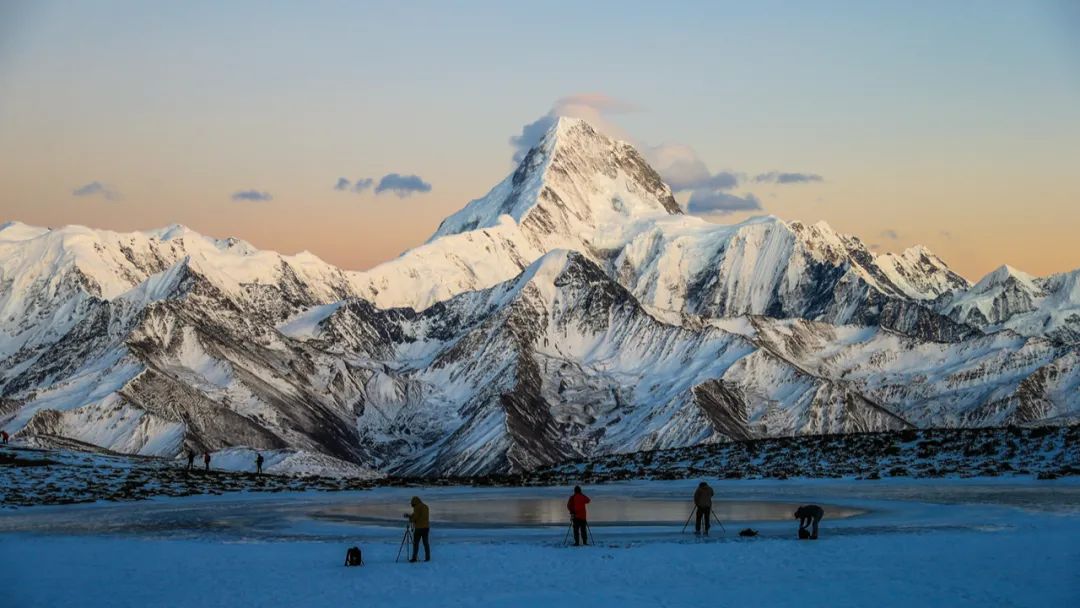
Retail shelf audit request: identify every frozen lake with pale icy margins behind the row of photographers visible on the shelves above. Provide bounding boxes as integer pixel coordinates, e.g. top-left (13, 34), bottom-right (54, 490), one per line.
top-left (0, 481), bottom-right (1080, 540)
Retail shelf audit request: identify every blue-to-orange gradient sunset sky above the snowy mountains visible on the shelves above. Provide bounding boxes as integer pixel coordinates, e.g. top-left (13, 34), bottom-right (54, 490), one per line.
top-left (0, 0), bottom-right (1080, 280)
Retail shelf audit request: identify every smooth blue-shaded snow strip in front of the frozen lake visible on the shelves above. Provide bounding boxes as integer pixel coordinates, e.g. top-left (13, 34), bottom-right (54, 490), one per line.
top-left (0, 519), bottom-right (1080, 608)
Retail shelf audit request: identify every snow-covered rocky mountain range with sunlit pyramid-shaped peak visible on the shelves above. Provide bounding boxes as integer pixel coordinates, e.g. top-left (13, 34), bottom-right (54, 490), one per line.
top-left (0, 119), bottom-right (1080, 474)
